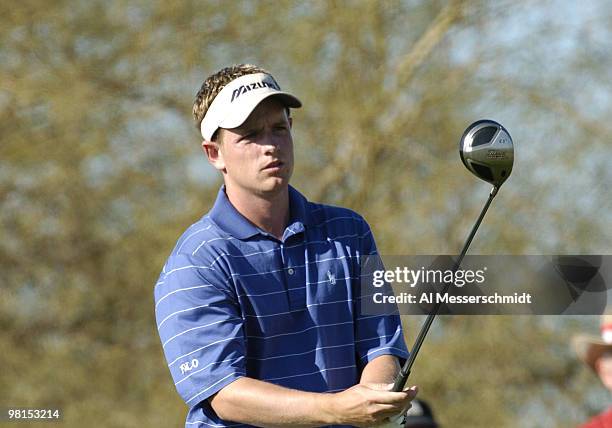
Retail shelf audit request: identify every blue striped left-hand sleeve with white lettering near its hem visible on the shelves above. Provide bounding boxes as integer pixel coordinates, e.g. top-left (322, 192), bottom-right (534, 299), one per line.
top-left (154, 254), bottom-right (246, 407)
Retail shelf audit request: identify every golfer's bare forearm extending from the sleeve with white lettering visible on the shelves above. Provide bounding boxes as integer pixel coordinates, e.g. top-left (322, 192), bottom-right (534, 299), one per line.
top-left (210, 377), bottom-right (336, 427)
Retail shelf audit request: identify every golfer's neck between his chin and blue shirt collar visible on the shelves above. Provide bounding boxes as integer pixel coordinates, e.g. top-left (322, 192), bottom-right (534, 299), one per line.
top-left (225, 186), bottom-right (289, 239)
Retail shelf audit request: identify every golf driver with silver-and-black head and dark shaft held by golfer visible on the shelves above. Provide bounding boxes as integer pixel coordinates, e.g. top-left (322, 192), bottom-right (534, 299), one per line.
top-left (392, 119), bottom-right (514, 392)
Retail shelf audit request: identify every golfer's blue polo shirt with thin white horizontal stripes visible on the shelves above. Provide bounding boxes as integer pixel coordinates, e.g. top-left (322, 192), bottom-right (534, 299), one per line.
top-left (154, 187), bottom-right (408, 428)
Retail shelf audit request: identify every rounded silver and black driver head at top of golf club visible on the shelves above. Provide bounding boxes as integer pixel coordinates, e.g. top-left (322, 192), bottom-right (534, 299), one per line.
top-left (459, 119), bottom-right (514, 188)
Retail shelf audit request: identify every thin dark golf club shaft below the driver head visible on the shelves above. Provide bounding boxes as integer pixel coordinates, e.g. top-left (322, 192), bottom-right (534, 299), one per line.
top-left (392, 186), bottom-right (499, 392)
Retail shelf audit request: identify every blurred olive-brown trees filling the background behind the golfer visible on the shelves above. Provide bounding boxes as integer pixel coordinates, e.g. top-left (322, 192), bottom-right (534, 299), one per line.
top-left (0, 0), bottom-right (612, 427)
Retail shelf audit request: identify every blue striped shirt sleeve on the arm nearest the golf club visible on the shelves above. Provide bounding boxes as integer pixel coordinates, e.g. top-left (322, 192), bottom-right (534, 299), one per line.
top-left (355, 220), bottom-right (408, 369)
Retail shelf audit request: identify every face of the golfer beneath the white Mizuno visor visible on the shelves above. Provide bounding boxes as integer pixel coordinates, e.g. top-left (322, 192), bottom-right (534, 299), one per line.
top-left (209, 98), bottom-right (293, 196)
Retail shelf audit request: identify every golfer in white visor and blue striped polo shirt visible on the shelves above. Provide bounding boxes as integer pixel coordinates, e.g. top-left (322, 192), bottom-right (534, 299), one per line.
top-left (155, 65), bottom-right (416, 427)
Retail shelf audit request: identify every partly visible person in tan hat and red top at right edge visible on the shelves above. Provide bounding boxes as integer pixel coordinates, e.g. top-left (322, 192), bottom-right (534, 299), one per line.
top-left (573, 314), bottom-right (612, 428)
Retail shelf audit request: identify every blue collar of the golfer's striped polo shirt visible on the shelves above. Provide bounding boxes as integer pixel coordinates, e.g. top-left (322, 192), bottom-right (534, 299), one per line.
top-left (209, 186), bottom-right (311, 239)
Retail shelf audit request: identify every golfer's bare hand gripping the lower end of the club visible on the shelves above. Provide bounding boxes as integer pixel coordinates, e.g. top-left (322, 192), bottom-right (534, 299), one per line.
top-left (332, 383), bottom-right (417, 427)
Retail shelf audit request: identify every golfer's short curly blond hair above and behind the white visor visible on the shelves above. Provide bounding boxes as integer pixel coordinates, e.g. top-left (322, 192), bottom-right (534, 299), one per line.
top-left (193, 64), bottom-right (270, 141)
